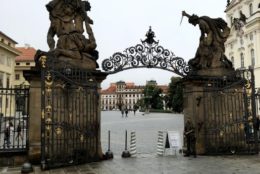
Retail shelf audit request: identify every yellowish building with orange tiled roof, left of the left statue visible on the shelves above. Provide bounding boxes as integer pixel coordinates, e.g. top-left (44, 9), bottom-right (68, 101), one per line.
top-left (13, 44), bottom-right (36, 86)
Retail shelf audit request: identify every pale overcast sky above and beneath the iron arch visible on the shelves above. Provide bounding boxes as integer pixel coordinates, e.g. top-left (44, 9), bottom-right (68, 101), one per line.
top-left (0, 0), bottom-right (226, 88)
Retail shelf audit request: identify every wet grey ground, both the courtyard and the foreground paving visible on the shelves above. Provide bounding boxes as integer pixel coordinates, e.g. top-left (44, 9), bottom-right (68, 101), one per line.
top-left (0, 111), bottom-right (260, 174)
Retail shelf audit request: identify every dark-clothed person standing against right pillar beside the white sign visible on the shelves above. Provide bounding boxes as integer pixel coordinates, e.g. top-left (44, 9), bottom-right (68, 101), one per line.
top-left (184, 117), bottom-right (197, 158)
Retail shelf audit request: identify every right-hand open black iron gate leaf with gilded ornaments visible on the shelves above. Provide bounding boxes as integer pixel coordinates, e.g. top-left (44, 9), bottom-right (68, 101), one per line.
top-left (203, 69), bottom-right (258, 154)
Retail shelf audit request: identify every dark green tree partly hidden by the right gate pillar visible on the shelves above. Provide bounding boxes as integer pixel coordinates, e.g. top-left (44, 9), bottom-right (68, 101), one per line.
top-left (166, 77), bottom-right (183, 113)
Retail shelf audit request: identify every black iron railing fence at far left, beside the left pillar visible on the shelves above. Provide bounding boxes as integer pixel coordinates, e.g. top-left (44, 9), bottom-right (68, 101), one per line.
top-left (0, 86), bottom-right (29, 153)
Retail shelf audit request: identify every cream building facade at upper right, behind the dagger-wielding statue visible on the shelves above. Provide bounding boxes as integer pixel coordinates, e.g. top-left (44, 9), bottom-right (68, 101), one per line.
top-left (225, 0), bottom-right (260, 88)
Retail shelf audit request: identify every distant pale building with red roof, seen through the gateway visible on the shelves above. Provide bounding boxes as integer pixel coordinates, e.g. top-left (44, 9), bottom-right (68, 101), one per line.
top-left (101, 81), bottom-right (168, 110)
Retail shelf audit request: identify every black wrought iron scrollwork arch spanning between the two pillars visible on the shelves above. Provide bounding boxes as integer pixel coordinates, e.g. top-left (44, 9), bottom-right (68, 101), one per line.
top-left (102, 28), bottom-right (190, 77)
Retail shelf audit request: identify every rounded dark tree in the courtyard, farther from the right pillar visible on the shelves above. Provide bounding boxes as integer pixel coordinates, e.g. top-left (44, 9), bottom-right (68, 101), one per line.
top-left (143, 85), bottom-right (163, 109)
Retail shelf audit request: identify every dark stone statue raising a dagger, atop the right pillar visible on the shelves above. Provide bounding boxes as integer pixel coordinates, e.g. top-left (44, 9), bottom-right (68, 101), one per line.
top-left (182, 11), bottom-right (232, 71)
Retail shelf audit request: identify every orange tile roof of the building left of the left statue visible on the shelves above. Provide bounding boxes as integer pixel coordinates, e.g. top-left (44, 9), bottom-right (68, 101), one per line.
top-left (15, 47), bottom-right (36, 62)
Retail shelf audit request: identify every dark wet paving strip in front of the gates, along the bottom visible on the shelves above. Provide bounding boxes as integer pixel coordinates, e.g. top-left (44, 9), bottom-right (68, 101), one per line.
top-left (0, 154), bottom-right (260, 174)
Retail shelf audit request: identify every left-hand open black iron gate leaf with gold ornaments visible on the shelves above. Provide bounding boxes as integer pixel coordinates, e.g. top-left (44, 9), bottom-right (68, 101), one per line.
top-left (40, 56), bottom-right (100, 169)
